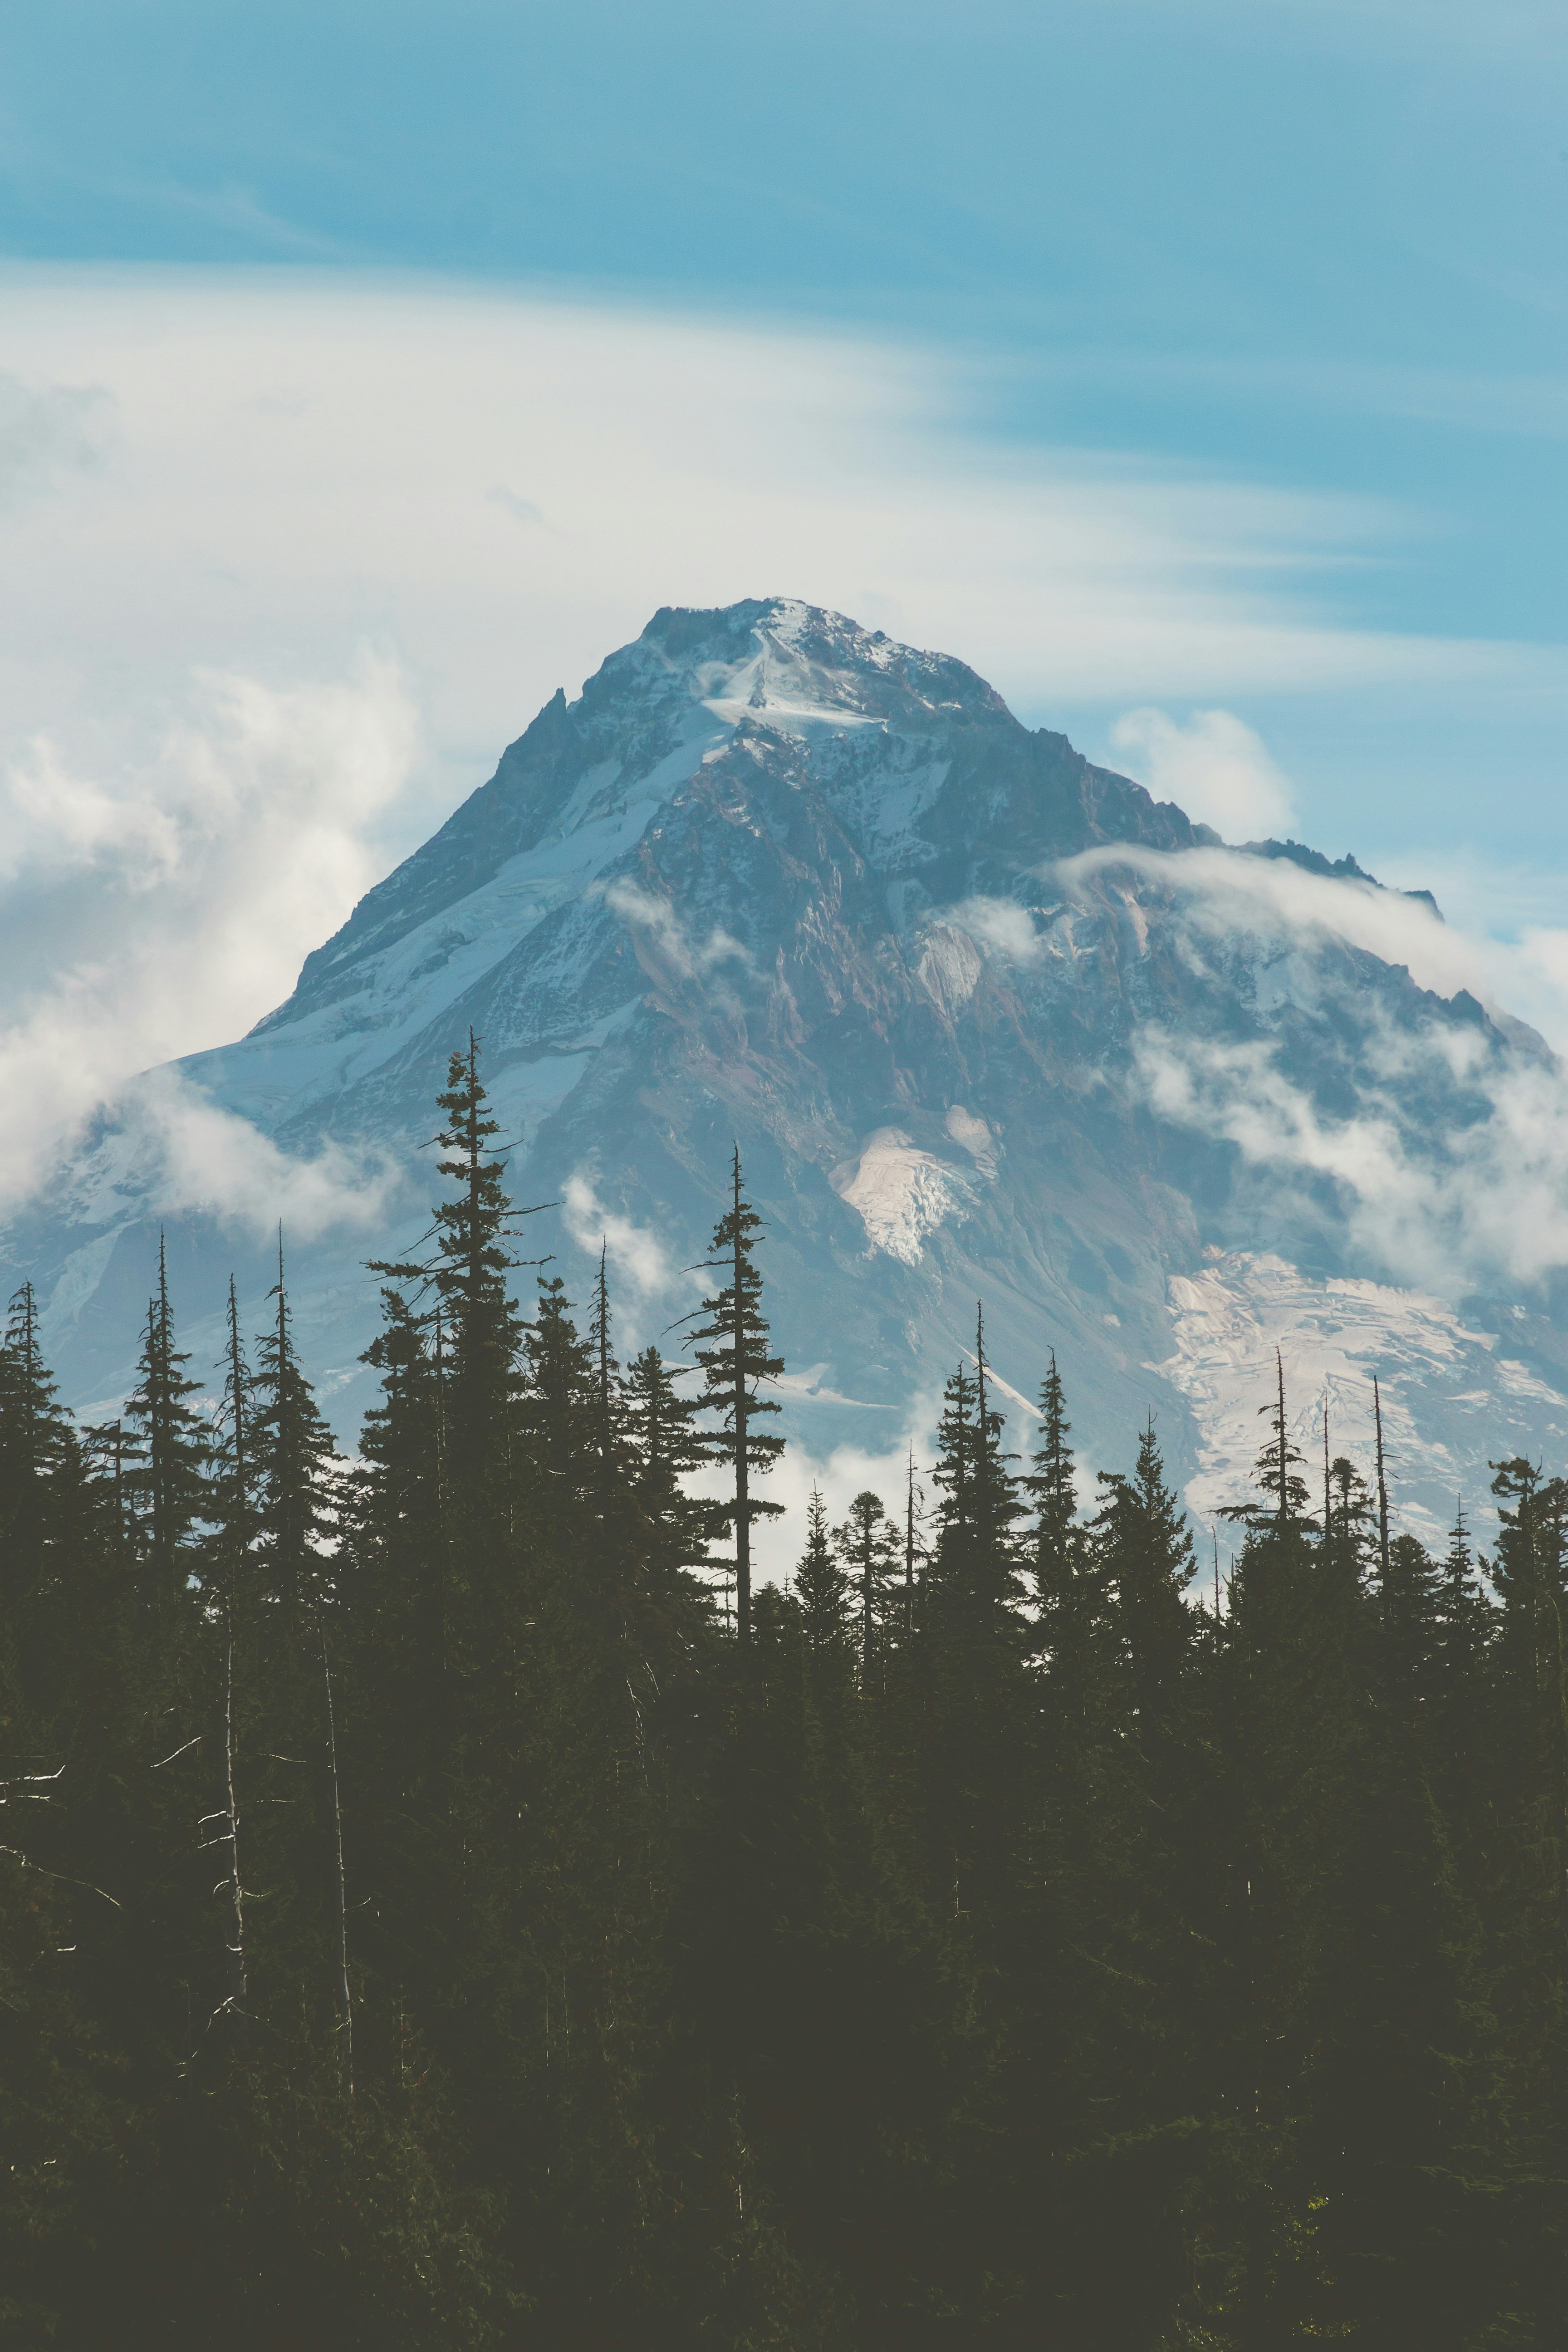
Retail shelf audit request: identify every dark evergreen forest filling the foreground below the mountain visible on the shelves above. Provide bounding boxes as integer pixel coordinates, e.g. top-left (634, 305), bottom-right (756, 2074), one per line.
top-left (0, 1039), bottom-right (1568, 2352)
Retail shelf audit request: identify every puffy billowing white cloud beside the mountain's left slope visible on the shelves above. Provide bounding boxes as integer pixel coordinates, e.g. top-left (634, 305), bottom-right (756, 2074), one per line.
top-left (0, 659), bottom-right (416, 1218)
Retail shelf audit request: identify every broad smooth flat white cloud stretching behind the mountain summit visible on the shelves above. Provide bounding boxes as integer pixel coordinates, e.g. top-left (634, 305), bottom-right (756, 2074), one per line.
top-left (0, 268), bottom-right (1556, 826)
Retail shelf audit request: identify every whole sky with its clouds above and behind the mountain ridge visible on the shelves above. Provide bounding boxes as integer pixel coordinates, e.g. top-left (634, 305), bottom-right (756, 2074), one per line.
top-left (0, 0), bottom-right (1568, 1176)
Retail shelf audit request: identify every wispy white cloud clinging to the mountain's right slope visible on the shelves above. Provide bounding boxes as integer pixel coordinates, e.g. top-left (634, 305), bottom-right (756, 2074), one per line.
top-left (1055, 849), bottom-right (1568, 1296)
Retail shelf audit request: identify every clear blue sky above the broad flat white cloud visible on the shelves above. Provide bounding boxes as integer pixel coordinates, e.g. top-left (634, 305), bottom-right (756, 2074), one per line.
top-left (0, 0), bottom-right (1568, 814)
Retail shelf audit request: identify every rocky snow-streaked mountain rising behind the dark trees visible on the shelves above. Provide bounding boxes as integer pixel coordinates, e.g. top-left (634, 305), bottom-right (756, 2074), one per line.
top-left (7, 600), bottom-right (1568, 1524)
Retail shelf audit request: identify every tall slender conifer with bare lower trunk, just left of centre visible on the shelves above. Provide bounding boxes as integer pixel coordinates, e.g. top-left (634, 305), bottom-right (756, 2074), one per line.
top-left (691, 1146), bottom-right (783, 1642)
